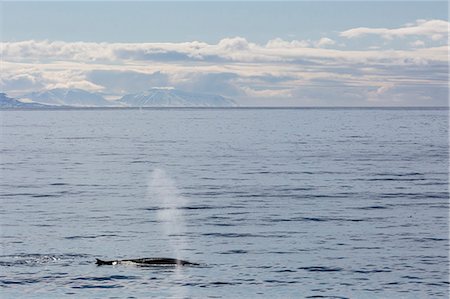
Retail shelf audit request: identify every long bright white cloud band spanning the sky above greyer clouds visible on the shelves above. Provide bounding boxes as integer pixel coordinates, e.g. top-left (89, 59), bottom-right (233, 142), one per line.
top-left (1, 36), bottom-right (448, 65)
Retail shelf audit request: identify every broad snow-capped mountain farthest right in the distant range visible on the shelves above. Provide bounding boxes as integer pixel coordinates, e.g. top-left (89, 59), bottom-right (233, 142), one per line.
top-left (118, 88), bottom-right (237, 107)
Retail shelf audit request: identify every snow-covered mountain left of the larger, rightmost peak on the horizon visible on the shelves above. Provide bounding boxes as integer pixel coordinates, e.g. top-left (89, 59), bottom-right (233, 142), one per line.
top-left (20, 88), bottom-right (114, 107)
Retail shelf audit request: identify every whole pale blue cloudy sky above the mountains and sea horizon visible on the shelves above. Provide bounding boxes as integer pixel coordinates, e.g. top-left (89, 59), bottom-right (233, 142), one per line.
top-left (0, 1), bottom-right (449, 106)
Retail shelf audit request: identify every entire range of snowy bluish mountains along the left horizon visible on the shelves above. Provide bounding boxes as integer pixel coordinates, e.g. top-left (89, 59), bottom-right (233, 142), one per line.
top-left (0, 88), bottom-right (237, 108)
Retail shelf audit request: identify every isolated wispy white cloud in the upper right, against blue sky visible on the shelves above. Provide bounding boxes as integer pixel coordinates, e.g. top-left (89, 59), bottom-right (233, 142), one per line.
top-left (340, 20), bottom-right (450, 40)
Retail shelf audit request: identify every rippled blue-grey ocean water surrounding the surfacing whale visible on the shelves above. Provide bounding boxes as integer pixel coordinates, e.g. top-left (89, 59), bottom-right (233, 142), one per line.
top-left (0, 108), bottom-right (449, 298)
